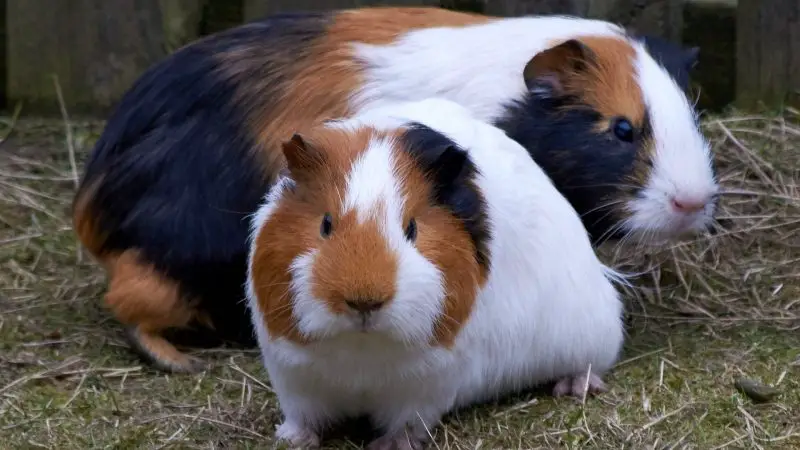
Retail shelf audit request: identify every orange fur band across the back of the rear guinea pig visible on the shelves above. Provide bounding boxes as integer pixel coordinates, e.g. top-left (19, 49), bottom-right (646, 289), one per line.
top-left (219, 7), bottom-right (493, 185)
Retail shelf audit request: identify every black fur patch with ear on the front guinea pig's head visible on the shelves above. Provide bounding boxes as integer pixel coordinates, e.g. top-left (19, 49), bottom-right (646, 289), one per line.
top-left (402, 123), bottom-right (491, 272)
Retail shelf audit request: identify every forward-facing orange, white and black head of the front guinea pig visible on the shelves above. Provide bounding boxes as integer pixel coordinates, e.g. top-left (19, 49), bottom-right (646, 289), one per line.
top-left (250, 125), bottom-right (488, 346)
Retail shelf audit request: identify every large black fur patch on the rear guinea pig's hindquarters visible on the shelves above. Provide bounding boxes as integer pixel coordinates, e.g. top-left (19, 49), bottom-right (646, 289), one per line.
top-left (77, 13), bottom-right (329, 345)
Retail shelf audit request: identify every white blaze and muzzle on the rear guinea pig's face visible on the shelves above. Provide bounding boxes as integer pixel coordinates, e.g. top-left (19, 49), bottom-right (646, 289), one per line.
top-left (628, 44), bottom-right (719, 240)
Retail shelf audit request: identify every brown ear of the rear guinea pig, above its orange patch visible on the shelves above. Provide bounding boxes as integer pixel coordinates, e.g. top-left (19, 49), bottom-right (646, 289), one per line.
top-left (522, 39), bottom-right (595, 95)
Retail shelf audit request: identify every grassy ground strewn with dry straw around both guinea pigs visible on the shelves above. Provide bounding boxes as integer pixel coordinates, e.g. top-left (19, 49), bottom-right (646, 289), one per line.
top-left (0, 111), bottom-right (800, 449)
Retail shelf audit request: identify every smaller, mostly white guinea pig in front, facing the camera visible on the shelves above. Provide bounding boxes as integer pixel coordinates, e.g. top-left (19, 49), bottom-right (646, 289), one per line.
top-left (247, 99), bottom-right (623, 449)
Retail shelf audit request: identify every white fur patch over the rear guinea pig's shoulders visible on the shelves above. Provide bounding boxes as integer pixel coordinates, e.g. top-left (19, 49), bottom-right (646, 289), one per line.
top-left (351, 16), bottom-right (622, 121)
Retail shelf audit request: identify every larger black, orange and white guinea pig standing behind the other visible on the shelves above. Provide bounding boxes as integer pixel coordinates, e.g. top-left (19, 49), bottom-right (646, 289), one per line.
top-left (73, 8), bottom-right (716, 371)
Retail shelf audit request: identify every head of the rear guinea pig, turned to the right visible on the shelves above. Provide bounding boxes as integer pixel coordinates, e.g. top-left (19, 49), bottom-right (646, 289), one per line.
top-left (506, 35), bottom-right (718, 246)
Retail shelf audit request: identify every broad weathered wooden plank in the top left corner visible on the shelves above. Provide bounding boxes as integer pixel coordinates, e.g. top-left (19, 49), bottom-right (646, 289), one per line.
top-left (7, 0), bottom-right (166, 114)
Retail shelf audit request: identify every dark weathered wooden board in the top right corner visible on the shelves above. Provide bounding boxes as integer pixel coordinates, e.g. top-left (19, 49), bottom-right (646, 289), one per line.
top-left (736, 0), bottom-right (800, 108)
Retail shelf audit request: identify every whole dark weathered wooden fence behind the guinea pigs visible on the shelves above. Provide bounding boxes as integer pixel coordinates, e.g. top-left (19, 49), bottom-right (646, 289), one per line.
top-left (0, 0), bottom-right (800, 115)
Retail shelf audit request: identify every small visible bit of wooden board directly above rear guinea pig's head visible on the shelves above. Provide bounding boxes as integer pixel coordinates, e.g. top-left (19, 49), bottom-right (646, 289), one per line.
top-left (587, 0), bottom-right (684, 42)
